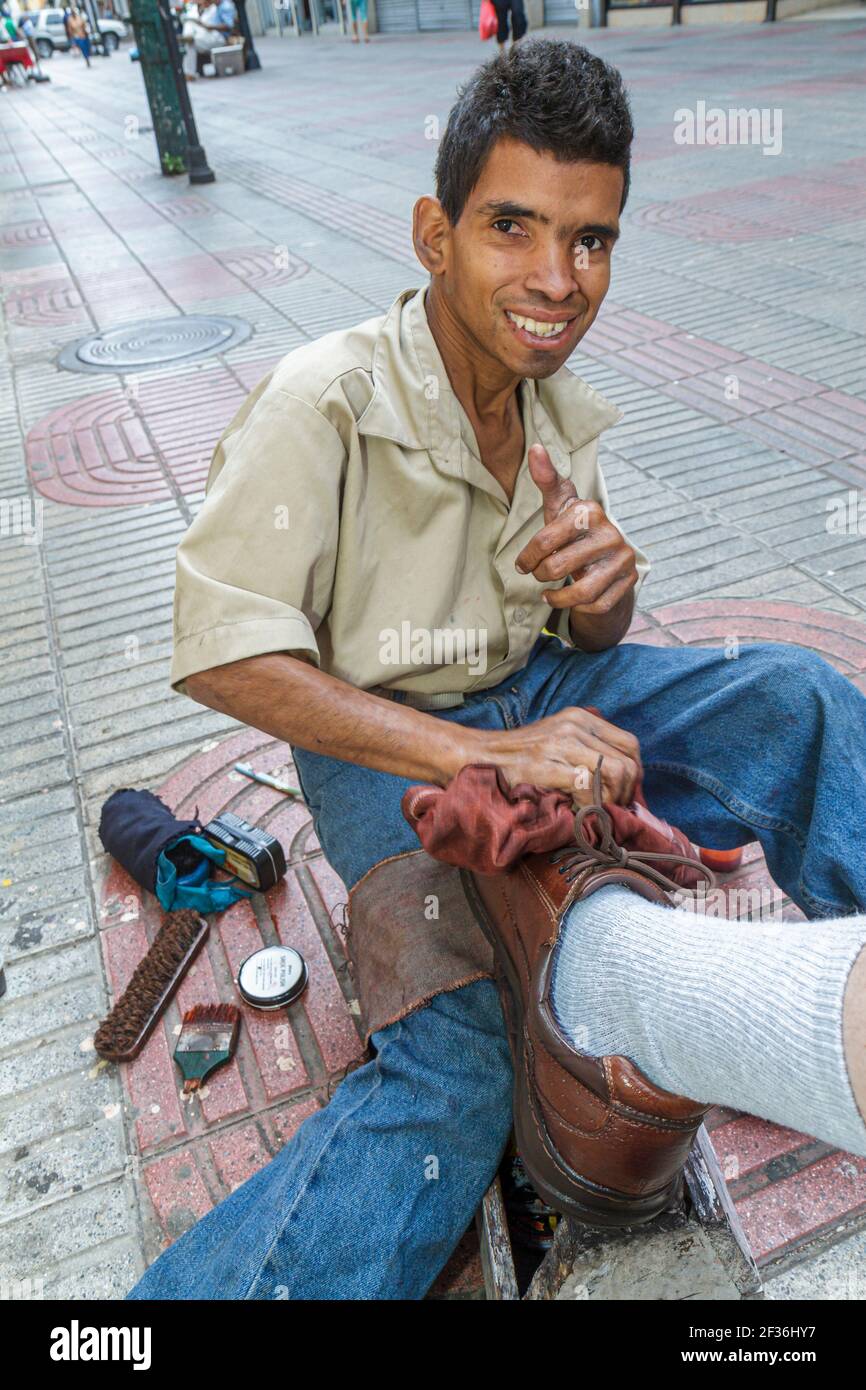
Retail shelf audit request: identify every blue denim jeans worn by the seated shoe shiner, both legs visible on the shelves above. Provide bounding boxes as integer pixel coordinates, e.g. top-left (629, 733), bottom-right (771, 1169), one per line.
top-left (129, 637), bottom-right (866, 1298)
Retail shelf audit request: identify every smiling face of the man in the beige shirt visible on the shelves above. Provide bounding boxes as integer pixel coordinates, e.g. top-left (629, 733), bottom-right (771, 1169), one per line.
top-left (442, 139), bottom-right (623, 377)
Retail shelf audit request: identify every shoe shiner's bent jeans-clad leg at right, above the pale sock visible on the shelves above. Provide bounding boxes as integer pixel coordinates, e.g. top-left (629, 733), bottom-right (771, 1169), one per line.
top-left (521, 639), bottom-right (866, 917)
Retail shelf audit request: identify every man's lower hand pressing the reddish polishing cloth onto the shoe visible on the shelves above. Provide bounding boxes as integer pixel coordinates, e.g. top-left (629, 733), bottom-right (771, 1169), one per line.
top-left (475, 708), bottom-right (641, 806)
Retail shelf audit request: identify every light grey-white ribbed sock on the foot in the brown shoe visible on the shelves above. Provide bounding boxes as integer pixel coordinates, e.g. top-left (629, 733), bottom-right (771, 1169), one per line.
top-left (550, 887), bottom-right (866, 1156)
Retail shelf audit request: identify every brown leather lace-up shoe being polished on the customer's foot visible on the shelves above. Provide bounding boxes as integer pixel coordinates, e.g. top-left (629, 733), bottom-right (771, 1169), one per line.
top-left (461, 777), bottom-right (714, 1226)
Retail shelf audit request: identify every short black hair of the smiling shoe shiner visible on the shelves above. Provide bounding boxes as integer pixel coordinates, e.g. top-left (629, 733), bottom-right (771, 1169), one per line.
top-left (435, 39), bottom-right (634, 227)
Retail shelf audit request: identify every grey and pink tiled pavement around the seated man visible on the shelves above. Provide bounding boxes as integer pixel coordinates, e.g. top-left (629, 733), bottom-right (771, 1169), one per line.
top-left (0, 21), bottom-right (866, 1298)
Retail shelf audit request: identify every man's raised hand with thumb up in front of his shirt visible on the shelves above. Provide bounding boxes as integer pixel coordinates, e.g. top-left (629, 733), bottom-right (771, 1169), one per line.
top-left (514, 443), bottom-right (638, 651)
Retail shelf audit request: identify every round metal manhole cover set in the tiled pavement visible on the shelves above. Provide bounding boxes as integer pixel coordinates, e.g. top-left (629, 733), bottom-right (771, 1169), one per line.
top-left (57, 314), bottom-right (252, 371)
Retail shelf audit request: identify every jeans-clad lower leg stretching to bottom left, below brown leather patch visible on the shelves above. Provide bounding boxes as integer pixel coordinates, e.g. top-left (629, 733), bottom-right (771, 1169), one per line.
top-left (129, 980), bottom-right (512, 1300)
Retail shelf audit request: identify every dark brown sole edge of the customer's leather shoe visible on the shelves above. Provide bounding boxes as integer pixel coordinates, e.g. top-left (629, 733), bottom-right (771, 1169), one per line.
top-left (460, 869), bottom-right (681, 1226)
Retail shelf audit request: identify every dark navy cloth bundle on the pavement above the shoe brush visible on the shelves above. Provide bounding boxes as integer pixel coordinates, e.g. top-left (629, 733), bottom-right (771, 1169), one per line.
top-left (99, 787), bottom-right (202, 892)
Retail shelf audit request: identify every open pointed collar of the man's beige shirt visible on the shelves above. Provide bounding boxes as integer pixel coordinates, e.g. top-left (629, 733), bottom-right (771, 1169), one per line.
top-left (359, 289), bottom-right (623, 477)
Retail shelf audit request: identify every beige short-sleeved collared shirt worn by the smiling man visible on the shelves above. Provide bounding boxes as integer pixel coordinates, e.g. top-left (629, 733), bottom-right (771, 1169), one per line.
top-left (171, 289), bottom-right (649, 698)
